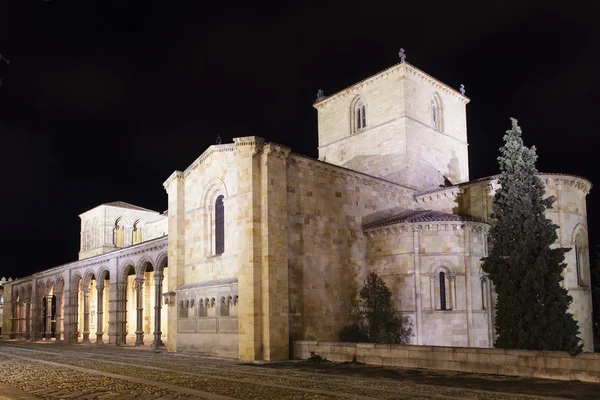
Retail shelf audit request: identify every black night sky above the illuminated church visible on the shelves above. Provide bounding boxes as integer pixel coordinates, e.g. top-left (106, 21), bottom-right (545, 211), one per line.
top-left (0, 0), bottom-right (600, 277)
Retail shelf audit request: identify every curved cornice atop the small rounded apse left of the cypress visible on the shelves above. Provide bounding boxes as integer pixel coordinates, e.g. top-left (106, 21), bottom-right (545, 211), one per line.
top-left (364, 221), bottom-right (490, 239)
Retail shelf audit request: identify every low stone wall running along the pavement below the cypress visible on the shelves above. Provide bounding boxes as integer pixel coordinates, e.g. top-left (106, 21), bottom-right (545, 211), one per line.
top-left (294, 340), bottom-right (600, 383)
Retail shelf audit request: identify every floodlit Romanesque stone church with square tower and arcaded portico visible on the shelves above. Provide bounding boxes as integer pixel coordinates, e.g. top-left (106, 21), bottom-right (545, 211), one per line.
top-left (3, 61), bottom-right (593, 360)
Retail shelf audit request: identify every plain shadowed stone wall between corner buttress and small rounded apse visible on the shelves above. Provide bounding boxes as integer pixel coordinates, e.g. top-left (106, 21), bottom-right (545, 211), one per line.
top-left (287, 154), bottom-right (414, 340)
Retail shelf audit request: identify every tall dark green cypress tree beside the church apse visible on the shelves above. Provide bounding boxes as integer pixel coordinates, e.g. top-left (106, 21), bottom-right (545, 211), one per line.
top-left (482, 118), bottom-right (582, 354)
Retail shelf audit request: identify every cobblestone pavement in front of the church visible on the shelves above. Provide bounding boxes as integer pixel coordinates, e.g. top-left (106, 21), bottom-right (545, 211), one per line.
top-left (0, 341), bottom-right (600, 400)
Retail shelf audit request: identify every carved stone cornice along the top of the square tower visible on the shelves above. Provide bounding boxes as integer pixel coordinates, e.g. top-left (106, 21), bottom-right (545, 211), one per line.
top-left (313, 61), bottom-right (470, 109)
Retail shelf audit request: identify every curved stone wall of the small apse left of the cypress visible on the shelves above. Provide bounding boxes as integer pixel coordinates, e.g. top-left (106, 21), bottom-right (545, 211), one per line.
top-left (366, 218), bottom-right (492, 347)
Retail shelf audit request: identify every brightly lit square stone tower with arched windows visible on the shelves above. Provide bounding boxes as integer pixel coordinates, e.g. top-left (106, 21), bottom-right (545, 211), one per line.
top-left (314, 62), bottom-right (469, 190)
